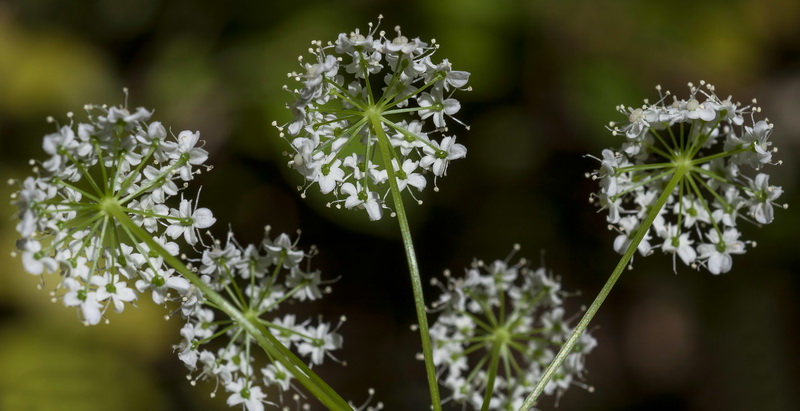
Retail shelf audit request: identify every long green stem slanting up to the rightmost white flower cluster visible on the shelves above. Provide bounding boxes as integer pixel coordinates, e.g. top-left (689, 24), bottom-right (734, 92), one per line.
top-left (520, 164), bottom-right (691, 411)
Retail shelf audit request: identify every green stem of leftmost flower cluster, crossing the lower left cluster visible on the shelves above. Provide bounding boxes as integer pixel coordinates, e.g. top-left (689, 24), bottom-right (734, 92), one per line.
top-left (103, 203), bottom-right (352, 410)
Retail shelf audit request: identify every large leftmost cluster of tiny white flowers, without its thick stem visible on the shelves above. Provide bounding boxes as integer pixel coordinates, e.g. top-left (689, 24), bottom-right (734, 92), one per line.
top-left (10, 99), bottom-right (215, 324)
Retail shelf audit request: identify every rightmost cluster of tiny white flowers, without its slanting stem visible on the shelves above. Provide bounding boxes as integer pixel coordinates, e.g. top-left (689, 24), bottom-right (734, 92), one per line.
top-left (591, 82), bottom-right (786, 274)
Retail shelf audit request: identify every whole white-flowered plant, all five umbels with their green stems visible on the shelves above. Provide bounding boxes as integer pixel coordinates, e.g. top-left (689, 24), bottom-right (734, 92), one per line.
top-left (6, 14), bottom-right (786, 411)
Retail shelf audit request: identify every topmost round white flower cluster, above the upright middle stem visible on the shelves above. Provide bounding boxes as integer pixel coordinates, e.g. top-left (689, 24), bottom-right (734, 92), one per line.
top-left (274, 15), bottom-right (469, 220)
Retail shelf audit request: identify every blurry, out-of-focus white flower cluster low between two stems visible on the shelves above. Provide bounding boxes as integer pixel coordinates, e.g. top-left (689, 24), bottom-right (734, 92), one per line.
top-left (430, 246), bottom-right (597, 410)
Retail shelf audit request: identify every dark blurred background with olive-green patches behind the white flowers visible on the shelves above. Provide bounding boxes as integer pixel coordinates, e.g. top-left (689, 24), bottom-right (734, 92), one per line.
top-left (0, 0), bottom-right (800, 411)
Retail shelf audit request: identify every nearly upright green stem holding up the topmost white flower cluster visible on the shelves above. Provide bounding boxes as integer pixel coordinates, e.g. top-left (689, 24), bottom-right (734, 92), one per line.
top-left (368, 112), bottom-right (442, 411)
